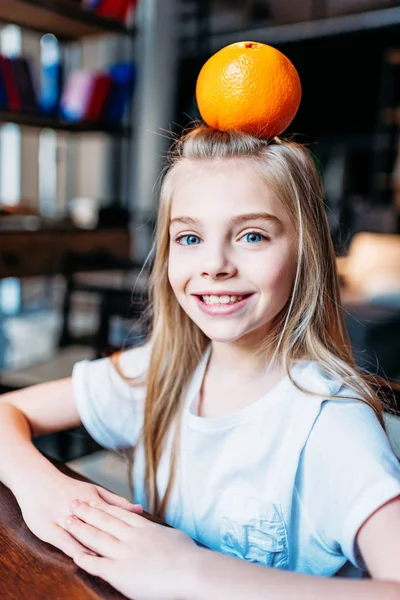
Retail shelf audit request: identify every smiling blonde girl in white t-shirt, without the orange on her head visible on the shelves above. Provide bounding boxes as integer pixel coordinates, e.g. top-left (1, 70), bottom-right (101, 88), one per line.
top-left (0, 126), bottom-right (400, 600)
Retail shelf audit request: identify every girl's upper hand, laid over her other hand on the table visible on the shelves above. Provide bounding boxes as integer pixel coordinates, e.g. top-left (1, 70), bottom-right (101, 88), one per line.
top-left (65, 500), bottom-right (197, 600)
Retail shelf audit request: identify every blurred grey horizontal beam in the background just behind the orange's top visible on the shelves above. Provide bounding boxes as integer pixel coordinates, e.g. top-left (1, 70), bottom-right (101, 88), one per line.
top-left (202, 7), bottom-right (400, 52)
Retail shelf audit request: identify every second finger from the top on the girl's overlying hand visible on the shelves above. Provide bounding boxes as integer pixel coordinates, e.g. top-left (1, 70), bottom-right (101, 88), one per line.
top-left (65, 515), bottom-right (121, 558)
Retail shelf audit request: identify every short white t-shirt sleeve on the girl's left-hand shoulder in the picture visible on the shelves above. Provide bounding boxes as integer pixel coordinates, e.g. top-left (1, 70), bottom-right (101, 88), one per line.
top-left (72, 347), bottom-right (150, 450)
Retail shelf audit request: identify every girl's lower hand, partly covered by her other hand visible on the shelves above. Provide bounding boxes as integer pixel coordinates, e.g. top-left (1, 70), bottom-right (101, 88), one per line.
top-left (17, 471), bottom-right (143, 558)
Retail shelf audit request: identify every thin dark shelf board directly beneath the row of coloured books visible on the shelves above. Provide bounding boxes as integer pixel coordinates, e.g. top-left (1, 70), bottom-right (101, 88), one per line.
top-left (0, 110), bottom-right (131, 135)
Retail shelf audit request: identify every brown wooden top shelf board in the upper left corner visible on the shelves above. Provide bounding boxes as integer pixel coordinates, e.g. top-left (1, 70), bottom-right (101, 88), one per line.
top-left (0, 0), bottom-right (134, 40)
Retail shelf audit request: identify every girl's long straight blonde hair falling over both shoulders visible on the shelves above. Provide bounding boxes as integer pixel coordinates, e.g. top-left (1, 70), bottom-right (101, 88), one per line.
top-left (114, 126), bottom-right (383, 517)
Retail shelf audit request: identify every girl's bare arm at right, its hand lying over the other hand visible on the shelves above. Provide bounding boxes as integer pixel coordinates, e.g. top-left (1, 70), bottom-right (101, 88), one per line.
top-left (66, 498), bottom-right (400, 600)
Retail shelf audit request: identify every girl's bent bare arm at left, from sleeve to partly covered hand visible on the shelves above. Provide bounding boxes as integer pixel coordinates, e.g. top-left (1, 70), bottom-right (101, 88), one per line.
top-left (0, 378), bottom-right (141, 556)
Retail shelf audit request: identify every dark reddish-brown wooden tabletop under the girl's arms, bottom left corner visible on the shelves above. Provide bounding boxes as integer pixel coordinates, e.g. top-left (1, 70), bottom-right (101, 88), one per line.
top-left (0, 461), bottom-right (161, 600)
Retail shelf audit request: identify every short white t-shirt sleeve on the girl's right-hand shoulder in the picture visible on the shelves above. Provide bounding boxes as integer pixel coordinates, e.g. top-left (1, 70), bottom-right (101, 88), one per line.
top-left (296, 400), bottom-right (400, 569)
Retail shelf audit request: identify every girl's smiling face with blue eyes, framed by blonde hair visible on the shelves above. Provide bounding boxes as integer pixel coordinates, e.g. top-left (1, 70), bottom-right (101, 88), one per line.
top-left (168, 159), bottom-right (296, 343)
